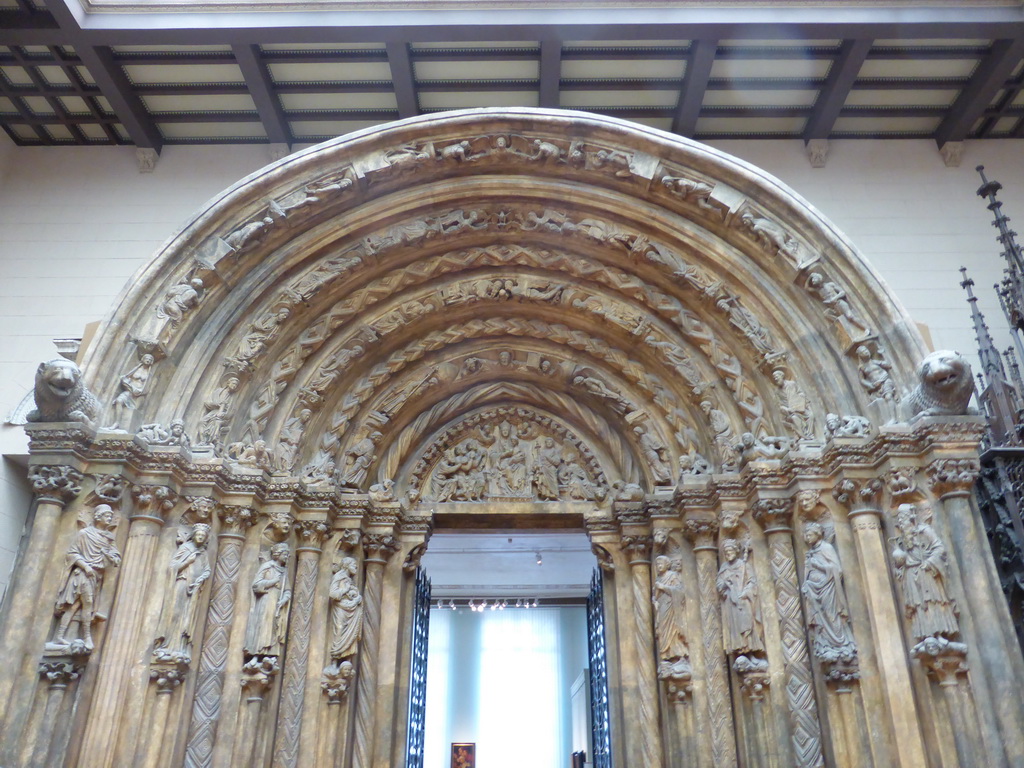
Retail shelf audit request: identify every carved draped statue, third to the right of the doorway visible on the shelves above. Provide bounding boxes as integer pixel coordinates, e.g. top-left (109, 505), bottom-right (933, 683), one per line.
top-left (801, 522), bottom-right (857, 663)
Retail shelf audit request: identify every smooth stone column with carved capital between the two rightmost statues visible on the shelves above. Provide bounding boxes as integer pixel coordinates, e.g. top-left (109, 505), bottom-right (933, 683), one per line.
top-left (833, 477), bottom-right (928, 768)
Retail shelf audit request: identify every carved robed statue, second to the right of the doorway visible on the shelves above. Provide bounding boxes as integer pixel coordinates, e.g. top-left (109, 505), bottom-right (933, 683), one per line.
top-left (717, 539), bottom-right (765, 653)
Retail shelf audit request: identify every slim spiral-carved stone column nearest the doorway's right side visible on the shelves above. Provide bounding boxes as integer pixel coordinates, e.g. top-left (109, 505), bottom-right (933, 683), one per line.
top-left (623, 535), bottom-right (663, 768)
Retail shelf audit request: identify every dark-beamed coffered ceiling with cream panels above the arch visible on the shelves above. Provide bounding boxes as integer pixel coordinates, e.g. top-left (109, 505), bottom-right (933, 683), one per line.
top-left (0, 0), bottom-right (1024, 151)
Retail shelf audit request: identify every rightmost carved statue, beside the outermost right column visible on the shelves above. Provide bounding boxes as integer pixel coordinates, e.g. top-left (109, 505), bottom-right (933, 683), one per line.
top-left (893, 504), bottom-right (959, 642)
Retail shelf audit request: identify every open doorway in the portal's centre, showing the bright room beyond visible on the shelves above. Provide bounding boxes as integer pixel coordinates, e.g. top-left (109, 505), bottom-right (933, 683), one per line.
top-left (422, 530), bottom-right (596, 768)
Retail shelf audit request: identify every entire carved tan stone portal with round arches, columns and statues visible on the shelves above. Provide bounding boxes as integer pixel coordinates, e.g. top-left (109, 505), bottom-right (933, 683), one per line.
top-left (0, 110), bottom-right (1024, 768)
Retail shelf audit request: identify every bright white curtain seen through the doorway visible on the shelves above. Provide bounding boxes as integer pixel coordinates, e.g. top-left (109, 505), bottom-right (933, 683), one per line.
top-left (424, 608), bottom-right (584, 768)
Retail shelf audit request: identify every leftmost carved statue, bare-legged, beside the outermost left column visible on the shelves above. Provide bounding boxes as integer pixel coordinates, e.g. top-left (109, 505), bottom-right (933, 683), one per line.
top-left (46, 504), bottom-right (121, 653)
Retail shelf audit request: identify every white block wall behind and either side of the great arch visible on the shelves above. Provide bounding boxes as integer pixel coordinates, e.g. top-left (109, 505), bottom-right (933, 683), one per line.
top-left (0, 135), bottom-right (1024, 602)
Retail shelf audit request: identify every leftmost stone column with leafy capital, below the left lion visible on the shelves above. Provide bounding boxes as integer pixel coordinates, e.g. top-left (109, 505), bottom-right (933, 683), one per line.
top-left (0, 465), bottom-right (82, 733)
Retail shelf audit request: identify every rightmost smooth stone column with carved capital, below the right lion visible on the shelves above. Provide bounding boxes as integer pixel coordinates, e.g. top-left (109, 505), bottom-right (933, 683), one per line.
top-left (928, 458), bottom-right (1024, 765)
